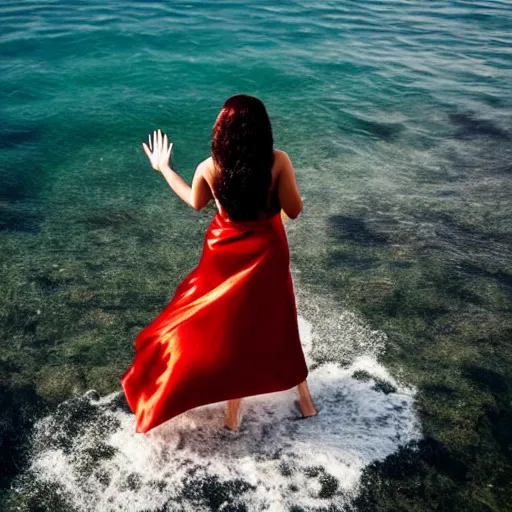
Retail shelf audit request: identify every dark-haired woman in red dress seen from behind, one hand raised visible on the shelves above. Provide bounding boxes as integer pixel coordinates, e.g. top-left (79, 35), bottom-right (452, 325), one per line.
top-left (121, 95), bottom-right (317, 432)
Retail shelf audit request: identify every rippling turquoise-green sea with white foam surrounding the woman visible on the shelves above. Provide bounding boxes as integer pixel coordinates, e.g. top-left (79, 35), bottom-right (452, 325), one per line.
top-left (0, 0), bottom-right (512, 511)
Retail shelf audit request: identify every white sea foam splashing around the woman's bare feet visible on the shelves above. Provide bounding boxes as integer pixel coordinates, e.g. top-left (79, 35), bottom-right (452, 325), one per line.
top-left (19, 302), bottom-right (420, 511)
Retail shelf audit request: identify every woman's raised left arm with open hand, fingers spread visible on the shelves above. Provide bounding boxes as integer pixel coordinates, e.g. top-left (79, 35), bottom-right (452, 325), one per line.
top-left (142, 130), bottom-right (213, 210)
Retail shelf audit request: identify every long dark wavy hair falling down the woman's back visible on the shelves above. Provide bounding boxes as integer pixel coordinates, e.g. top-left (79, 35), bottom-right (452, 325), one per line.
top-left (212, 94), bottom-right (274, 221)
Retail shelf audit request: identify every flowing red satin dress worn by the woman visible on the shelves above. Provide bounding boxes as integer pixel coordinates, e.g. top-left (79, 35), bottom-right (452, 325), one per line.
top-left (121, 208), bottom-right (308, 432)
